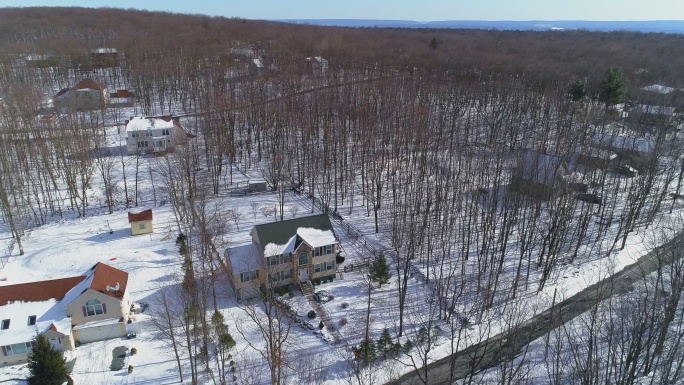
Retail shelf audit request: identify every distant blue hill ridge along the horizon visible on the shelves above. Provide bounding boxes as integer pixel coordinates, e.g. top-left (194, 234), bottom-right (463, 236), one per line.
top-left (274, 19), bottom-right (684, 34)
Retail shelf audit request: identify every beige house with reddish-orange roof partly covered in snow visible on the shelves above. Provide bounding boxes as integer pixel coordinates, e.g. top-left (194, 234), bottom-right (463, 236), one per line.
top-left (0, 263), bottom-right (132, 365)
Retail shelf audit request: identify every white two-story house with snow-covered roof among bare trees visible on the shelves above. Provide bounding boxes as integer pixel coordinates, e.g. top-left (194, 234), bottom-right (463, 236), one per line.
top-left (126, 116), bottom-right (188, 155)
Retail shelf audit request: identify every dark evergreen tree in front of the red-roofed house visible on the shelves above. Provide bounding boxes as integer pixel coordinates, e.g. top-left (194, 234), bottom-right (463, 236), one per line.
top-left (27, 334), bottom-right (69, 385)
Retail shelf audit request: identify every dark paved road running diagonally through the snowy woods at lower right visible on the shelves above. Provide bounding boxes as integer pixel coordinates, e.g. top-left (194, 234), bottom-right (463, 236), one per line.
top-left (392, 233), bottom-right (684, 385)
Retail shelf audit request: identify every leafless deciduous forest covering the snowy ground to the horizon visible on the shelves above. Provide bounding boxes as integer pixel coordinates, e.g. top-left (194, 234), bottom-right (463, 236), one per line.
top-left (0, 8), bottom-right (684, 384)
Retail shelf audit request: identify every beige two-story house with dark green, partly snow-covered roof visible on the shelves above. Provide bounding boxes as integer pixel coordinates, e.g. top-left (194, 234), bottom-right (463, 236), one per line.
top-left (226, 214), bottom-right (340, 300)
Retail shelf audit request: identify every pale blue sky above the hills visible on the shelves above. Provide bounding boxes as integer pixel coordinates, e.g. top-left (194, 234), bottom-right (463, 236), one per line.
top-left (0, 0), bottom-right (684, 21)
